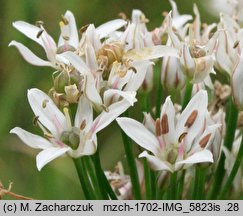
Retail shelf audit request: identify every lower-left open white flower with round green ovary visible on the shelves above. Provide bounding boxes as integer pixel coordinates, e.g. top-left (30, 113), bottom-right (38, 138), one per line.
top-left (10, 89), bottom-right (136, 170)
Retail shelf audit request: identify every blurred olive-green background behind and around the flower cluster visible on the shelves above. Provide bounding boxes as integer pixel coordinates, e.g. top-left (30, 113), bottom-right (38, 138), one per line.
top-left (0, 0), bottom-right (215, 199)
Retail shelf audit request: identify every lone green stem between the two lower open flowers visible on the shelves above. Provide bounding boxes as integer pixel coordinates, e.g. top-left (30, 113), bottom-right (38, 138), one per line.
top-left (121, 113), bottom-right (141, 200)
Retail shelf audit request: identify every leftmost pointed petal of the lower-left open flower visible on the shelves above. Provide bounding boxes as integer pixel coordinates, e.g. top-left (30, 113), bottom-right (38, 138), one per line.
top-left (10, 127), bottom-right (52, 149)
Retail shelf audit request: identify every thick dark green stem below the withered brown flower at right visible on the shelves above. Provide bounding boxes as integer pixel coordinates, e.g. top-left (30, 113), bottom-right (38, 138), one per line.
top-left (209, 99), bottom-right (238, 199)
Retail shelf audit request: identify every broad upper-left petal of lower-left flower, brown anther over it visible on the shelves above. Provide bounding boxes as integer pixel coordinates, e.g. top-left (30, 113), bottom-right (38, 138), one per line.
top-left (28, 88), bottom-right (67, 138)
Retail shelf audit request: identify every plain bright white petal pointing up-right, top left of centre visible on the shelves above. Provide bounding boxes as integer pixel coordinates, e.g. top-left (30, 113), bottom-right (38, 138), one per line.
top-left (96, 19), bottom-right (127, 39)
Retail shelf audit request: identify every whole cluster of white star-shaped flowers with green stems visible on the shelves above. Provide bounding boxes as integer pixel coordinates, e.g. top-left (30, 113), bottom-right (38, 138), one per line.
top-left (9, 0), bottom-right (243, 199)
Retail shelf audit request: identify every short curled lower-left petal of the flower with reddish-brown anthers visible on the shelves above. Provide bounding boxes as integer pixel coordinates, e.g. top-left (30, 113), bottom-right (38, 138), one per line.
top-left (138, 151), bottom-right (173, 172)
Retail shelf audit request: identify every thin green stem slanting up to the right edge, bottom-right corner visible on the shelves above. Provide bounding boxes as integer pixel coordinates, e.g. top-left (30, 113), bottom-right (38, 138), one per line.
top-left (219, 136), bottom-right (243, 199)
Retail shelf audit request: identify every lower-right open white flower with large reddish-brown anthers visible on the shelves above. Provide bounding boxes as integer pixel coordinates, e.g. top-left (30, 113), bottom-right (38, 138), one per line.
top-left (117, 90), bottom-right (220, 172)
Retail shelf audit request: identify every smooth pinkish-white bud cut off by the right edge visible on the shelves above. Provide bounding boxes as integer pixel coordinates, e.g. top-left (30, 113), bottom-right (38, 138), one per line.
top-left (231, 56), bottom-right (243, 109)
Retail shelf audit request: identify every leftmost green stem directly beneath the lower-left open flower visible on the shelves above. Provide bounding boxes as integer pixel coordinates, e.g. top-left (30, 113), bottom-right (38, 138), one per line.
top-left (73, 158), bottom-right (94, 200)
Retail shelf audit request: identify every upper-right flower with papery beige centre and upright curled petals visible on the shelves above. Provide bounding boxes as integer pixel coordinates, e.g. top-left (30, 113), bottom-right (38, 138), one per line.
top-left (166, 6), bottom-right (214, 83)
